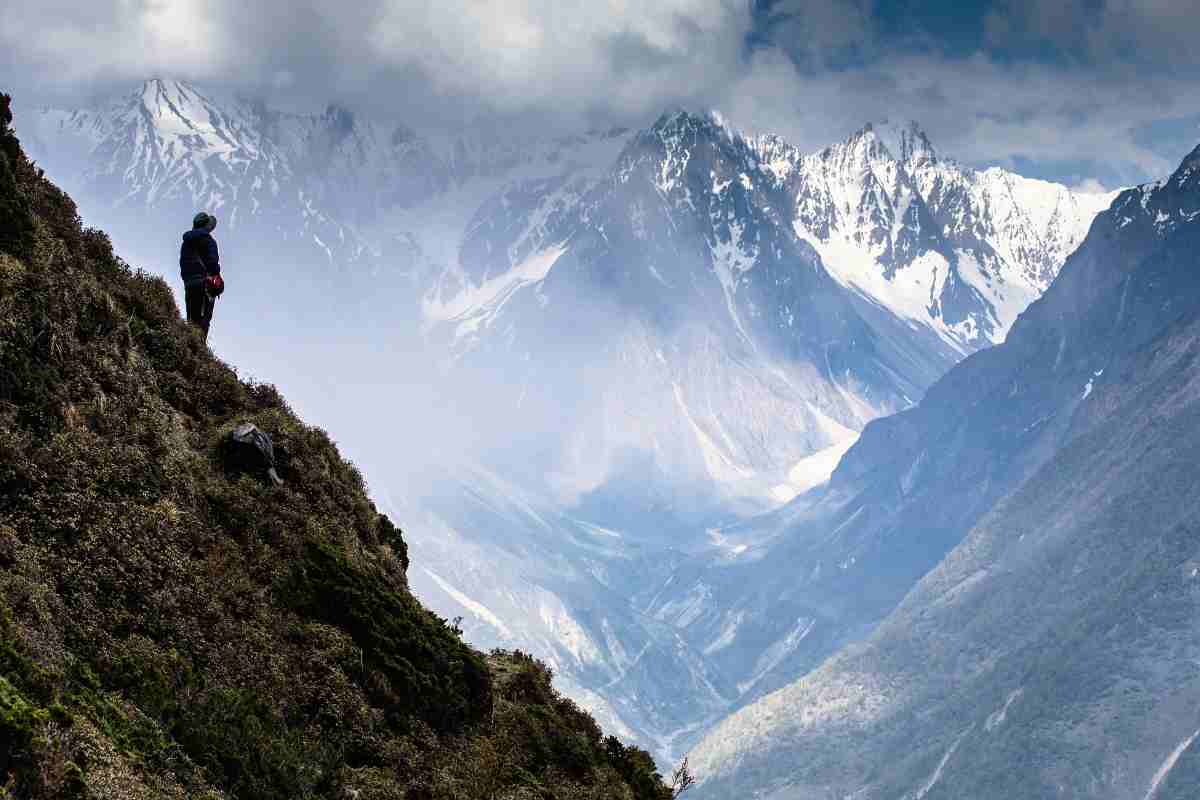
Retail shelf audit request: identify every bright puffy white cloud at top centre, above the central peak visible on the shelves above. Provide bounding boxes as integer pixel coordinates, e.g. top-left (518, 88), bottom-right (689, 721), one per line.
top-left (368, 0), bottom-right (749, 110)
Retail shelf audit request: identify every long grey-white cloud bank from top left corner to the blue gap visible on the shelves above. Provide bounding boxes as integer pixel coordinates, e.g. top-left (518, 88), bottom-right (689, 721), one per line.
top-left (0, 0), bottom-right (751, 122)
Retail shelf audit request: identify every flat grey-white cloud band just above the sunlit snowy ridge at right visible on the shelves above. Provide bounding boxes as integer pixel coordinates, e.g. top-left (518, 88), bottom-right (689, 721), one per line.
top-left (720, 54), bottom-right (1200, 184)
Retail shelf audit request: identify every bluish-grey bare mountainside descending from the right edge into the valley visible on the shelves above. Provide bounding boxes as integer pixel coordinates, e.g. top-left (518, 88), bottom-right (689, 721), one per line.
top-left (694, 149), bottom-right (1200, 800)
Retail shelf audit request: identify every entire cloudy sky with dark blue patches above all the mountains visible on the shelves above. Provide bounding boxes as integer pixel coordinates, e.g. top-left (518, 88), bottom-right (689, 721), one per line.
top-left (0, 0), bottom-right (1200, 187)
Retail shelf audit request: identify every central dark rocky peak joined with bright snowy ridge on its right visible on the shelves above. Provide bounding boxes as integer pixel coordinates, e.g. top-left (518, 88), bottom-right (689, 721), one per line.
top-left (425, 112), bottom-right (1112, 501)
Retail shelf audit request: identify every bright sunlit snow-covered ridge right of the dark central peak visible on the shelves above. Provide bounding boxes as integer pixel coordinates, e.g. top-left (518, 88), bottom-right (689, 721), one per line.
top-left (754, 122), bottom-right (1116, 354)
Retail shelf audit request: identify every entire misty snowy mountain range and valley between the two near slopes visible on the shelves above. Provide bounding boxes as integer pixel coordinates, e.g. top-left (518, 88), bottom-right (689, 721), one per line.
top-left (20, 80), bottom-right (1112, 756)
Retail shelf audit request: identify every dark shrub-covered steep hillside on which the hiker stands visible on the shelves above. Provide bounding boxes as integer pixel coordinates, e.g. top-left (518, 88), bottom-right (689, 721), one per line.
top-left (0, 96), bottom-right (671, 800)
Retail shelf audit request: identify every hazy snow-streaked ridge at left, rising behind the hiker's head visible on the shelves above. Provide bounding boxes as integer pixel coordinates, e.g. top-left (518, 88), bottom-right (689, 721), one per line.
top-left (22, 79), bottom-right (623, 291)
